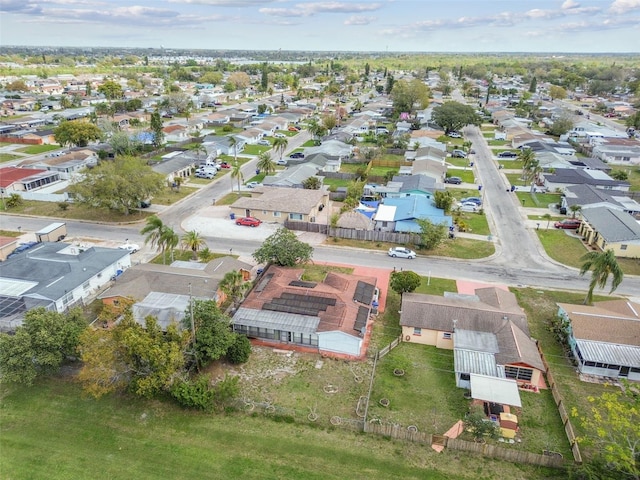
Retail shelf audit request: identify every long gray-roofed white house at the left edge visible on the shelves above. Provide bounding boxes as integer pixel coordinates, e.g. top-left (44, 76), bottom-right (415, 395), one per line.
top-left (0, 242), bottom-right (131, 330)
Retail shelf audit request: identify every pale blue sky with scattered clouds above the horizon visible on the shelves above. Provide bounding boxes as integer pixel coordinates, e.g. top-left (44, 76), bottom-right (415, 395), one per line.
top-left (0, 0), bottom-right (640, 53)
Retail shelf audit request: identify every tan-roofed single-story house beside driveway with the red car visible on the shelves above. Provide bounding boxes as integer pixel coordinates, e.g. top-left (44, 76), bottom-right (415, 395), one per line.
top-left (231, 186), bottom-right (329, 223)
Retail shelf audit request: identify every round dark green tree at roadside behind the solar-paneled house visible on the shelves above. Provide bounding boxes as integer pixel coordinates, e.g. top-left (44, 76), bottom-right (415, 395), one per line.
top-left (253, 227), bottom-right (313, 267)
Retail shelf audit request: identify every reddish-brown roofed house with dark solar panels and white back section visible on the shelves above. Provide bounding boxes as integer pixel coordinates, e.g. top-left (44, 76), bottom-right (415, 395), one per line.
top-left (232, 265), bottom-right (376, 358)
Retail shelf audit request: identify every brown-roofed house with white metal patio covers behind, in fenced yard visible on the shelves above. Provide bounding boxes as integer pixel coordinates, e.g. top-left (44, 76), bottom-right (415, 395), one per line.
top-left (400, 287), bottom-right (544, 406)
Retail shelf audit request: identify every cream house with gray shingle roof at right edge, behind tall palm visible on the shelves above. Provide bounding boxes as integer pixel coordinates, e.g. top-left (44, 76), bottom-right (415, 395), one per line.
top-left (577, 207), bottom-right (640, 258)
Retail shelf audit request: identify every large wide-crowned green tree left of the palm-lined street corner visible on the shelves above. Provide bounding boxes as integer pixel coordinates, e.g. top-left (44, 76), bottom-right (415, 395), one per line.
top-left (69, 156), bottom-right (165, 215)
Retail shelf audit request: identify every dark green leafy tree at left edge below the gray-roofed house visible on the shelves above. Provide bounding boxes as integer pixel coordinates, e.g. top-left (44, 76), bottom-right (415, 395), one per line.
top-left (0, 307), bottom-right (87, 385)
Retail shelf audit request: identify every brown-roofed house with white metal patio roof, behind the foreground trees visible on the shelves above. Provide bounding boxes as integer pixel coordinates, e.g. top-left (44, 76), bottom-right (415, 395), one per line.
top-left (98, 257), bottom-right (251, 330)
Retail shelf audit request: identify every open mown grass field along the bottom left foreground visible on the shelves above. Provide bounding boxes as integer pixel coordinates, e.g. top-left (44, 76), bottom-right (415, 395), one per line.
top-left (0, 379), bottom-right (562, 480)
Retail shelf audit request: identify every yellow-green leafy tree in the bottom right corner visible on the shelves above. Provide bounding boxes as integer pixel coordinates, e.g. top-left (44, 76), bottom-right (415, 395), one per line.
top-left (572, 382), bottom-right (640, 480)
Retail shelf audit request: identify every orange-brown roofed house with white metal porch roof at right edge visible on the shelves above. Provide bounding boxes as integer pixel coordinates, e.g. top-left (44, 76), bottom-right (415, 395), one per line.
top-left (557, 299), bottom-right (640, 381)
